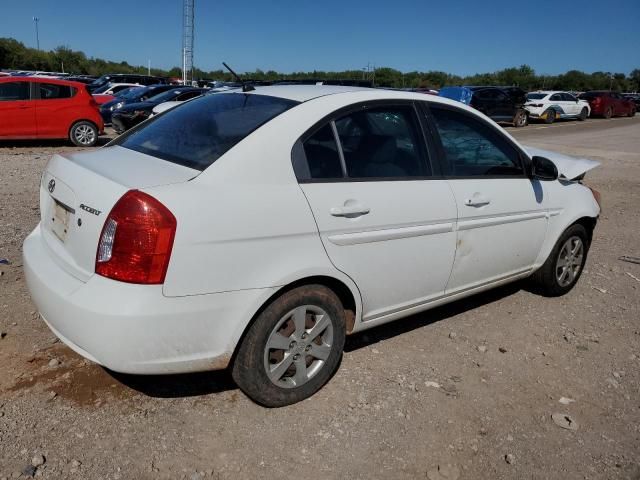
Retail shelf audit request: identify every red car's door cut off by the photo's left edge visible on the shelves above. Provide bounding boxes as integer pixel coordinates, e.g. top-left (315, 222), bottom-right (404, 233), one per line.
top-left (0, 80), bottom-right (37, 138)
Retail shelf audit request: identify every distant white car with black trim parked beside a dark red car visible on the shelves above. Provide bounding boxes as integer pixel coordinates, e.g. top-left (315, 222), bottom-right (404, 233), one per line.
top-left (524, 91), bottom-right (591, 123)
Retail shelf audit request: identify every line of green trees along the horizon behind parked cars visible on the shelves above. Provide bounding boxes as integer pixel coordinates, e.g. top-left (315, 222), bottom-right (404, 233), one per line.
top-left (0, 38), bottom-right (640, 92)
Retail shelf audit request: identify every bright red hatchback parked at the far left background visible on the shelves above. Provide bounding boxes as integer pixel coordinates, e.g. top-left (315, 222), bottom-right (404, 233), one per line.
top-left (0, 77), bottom-right (104, 147)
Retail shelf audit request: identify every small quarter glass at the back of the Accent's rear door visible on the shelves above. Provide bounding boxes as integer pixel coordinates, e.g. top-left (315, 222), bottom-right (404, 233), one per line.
top-left (304, 123), bottom-right (344, 179)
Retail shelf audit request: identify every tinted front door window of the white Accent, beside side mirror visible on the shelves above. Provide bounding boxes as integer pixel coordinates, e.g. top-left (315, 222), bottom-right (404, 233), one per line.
top-left (431, 107), bottom-right (523, 177)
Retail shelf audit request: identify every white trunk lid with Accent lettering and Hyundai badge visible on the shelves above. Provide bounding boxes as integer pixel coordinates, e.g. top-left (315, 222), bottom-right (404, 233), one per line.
top-left (40, 146), bottom-right (200, 281)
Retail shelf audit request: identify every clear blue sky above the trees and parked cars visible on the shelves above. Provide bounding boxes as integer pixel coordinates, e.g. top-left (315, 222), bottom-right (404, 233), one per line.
top-left (0, 0), bottom-right (640, 75)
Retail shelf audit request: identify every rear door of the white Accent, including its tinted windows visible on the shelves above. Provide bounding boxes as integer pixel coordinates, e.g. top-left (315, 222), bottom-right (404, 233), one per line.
top-left (294, 102), bottom-right (456, 320)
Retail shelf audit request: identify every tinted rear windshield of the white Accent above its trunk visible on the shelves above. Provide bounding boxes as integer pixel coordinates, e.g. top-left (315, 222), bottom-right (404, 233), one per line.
top-left (112, 93), bottom-right (298, 170)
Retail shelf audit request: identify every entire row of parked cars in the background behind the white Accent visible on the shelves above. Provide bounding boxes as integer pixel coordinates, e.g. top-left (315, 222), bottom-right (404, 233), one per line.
top-left (0, 72), bottom-right (640, 146)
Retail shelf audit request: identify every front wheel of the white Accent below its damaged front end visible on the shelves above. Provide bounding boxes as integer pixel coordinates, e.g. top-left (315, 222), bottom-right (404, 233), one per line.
top-left (531, 224), bottom-right (589, 297)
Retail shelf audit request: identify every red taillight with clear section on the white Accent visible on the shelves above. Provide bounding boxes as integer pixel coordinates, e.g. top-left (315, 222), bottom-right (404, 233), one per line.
top-left (96, 190), bottom-right (177, 284)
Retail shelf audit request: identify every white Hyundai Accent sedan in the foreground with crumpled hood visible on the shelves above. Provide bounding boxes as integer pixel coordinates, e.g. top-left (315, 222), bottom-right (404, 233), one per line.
top-left (24, 85), bottom-right (600, 406)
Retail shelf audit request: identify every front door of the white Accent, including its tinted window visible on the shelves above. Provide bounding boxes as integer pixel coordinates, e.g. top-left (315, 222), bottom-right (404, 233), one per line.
top-left (431, 106), bottom-right (547, 293)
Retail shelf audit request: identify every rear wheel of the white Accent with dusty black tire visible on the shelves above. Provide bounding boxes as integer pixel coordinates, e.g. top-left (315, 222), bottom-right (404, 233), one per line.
top-left (231, 285), bottom-right (346, 407)
